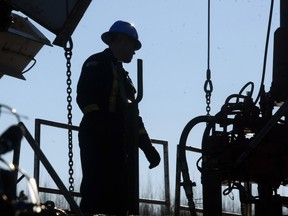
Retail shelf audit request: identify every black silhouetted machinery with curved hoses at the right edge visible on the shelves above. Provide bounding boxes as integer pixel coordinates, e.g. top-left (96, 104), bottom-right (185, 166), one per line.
top-left (175, 0), bottom-right (288, 216)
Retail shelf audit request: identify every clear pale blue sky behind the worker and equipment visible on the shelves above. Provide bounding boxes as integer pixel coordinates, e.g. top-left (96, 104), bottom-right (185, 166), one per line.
top-left (0, 0), bottom-right (279, 211)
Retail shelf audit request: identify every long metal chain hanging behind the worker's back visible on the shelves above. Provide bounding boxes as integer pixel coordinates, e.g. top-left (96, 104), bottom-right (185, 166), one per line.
top-left (64, 37), bottom-right (74, 191)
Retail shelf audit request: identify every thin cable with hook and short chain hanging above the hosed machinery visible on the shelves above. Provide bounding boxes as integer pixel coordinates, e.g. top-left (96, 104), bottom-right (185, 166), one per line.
top-left (204, 0), bottom-right (213, 116)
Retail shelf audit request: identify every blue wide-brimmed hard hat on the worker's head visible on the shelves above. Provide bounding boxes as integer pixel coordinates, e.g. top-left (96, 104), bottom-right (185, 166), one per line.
top-left (101, 20), bottom-right (142, 50)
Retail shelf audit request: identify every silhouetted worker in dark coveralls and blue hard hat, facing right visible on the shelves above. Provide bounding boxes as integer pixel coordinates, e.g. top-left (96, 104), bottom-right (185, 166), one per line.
top-left (77, 21), bottom-right (160, 215)
